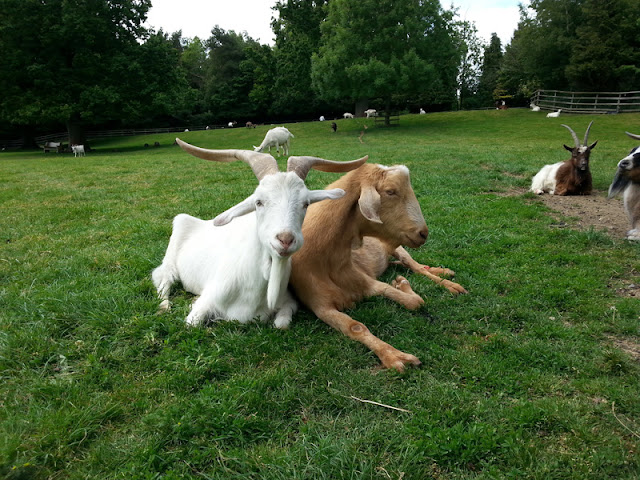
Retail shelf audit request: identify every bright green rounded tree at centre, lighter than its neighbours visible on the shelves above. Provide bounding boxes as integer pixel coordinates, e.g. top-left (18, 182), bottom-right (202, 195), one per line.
top-left (312, 0), bottom-right (459, 120)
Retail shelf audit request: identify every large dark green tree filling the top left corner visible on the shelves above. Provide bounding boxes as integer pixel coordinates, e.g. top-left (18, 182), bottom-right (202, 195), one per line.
top-left (0, 0), bottom-right (189, 143)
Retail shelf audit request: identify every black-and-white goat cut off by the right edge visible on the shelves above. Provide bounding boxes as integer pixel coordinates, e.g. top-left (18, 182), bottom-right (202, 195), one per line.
top-left (609, 132), bottom-right (640, 241)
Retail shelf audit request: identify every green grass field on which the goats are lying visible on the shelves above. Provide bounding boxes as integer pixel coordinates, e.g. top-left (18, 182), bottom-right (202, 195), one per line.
top-left (0, 110), bottom-right (640, 480)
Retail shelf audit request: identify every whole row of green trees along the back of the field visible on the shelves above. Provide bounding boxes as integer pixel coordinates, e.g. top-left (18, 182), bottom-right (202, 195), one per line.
top-left (0, 0), bottom-right (640, 143)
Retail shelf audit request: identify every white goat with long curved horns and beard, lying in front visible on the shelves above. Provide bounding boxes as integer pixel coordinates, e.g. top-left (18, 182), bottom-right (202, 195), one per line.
top-left (152, 139), bottom-right (367, 328)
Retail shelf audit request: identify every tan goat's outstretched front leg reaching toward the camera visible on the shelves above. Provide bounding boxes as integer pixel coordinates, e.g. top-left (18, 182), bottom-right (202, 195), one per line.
top-left (314, 308), bottom-right (421, 372)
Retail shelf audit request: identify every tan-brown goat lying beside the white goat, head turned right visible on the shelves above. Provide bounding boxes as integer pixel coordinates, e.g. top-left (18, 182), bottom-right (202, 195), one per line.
top-left (289, 164), bottom-right (466, 371)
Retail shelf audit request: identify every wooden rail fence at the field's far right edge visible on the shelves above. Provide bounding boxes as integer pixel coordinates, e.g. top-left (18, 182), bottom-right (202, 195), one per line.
top-left (531, 90), bottom-right (640, 113)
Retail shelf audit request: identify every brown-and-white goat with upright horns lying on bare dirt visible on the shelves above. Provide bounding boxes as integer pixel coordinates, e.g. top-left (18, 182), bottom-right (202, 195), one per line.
top-left (531, 121), bottom-right (598, 195)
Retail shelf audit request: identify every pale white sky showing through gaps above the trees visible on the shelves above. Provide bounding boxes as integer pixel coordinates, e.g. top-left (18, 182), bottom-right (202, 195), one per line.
top-left (147, 0), bottom-right (528, 46)
